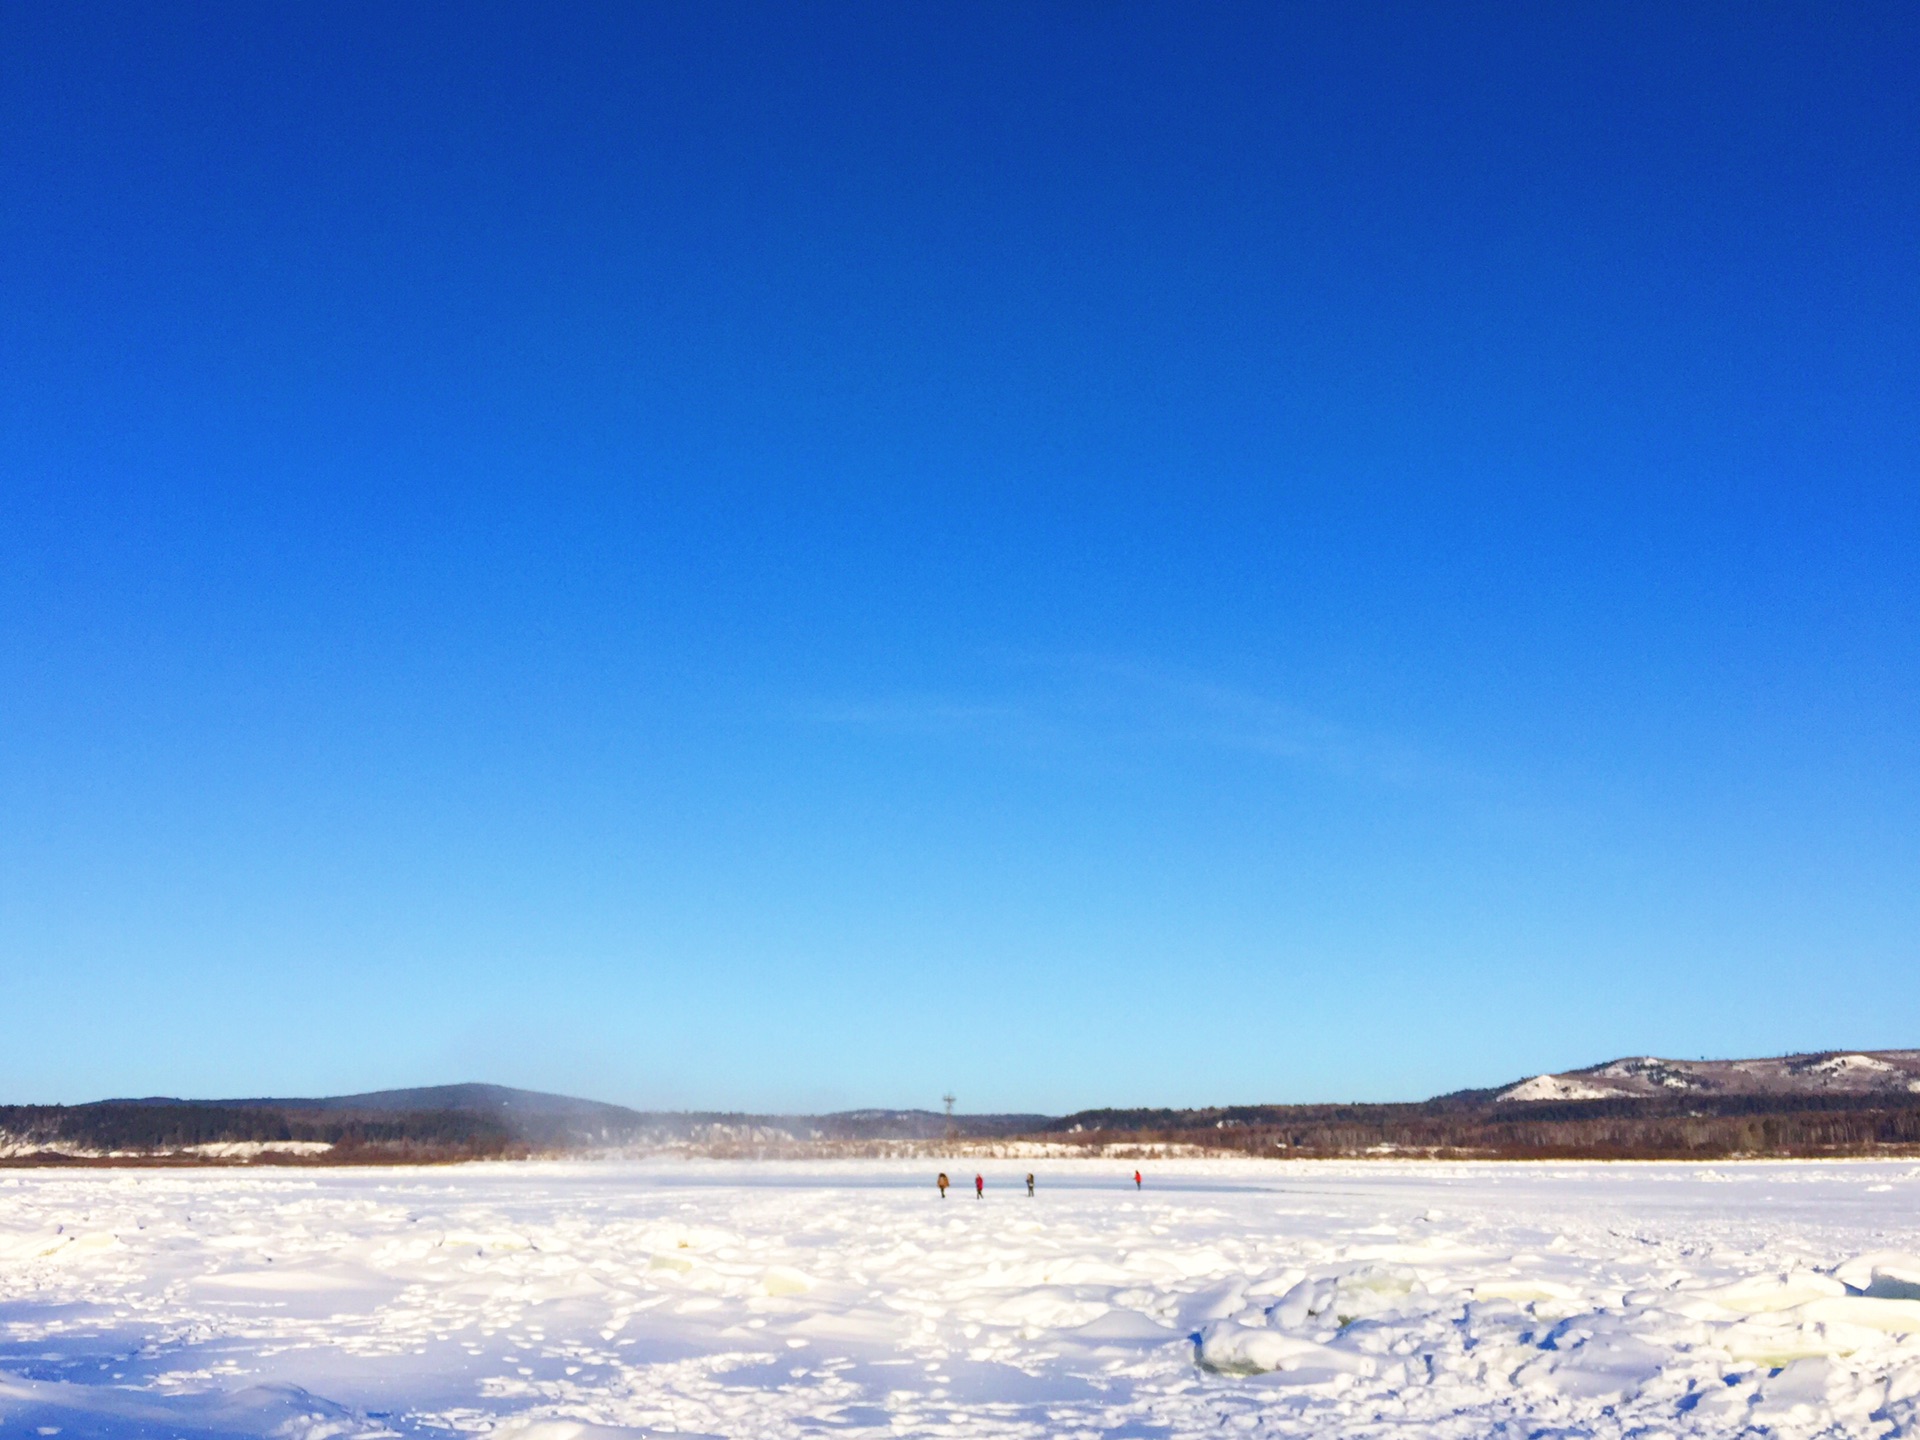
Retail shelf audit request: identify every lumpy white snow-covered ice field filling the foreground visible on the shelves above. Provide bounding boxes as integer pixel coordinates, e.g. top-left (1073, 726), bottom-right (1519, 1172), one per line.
top-left (0, 1162), bottom-right (1920, 1440)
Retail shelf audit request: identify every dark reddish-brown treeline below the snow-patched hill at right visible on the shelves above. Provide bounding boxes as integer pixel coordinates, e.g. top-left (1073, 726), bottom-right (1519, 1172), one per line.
top-left (1048, 1094), bottom-right (1920, 1158)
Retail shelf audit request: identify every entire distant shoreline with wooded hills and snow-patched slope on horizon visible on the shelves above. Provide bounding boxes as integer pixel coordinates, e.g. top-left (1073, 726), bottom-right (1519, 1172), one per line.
top-left (0, 1050), bottom-right (1920, 1169)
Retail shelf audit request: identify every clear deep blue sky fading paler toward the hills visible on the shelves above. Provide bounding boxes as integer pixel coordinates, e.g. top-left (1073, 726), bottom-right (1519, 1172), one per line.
top-left (0, 4), bottom-right (1920, 1110)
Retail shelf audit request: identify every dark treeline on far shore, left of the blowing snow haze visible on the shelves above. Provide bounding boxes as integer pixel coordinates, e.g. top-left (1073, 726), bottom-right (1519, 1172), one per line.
top-left (0, 1102), bottom-right (515, 1162)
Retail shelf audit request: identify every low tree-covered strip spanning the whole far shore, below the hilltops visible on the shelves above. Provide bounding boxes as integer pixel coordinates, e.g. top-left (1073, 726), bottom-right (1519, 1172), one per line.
top-left (15, 1091), bottom-right (1920, 1164)
